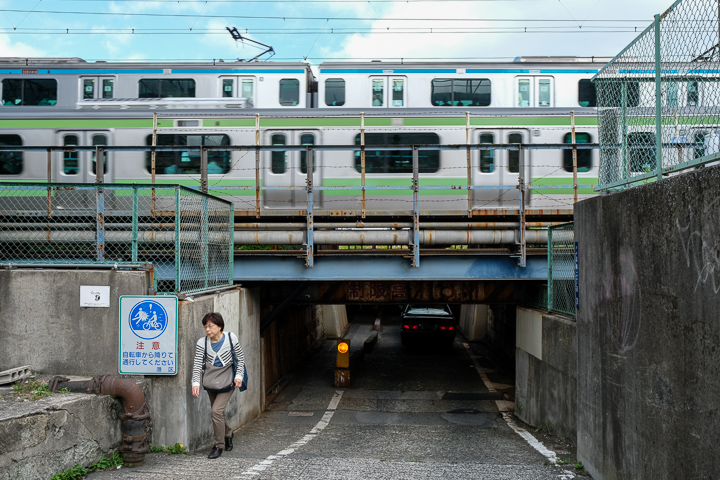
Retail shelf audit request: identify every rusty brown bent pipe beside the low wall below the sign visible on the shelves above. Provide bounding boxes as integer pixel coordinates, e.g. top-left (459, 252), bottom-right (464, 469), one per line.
top-left (48, 375), bottom-right (150, 466)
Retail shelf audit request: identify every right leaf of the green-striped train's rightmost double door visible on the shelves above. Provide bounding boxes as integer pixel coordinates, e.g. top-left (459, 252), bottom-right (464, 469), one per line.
top-left (496, 129), bottom-right (530, 208)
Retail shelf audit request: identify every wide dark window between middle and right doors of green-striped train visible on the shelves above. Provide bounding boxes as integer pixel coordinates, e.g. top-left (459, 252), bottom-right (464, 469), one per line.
top-left (355, 133), bottom-right (440, 173)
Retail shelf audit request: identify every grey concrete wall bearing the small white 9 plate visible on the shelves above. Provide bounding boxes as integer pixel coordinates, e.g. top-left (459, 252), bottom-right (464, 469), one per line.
top-left (0, 268), bottom-right (150, 377)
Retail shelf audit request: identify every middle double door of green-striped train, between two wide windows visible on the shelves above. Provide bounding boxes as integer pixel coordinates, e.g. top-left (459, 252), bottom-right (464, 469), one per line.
top-left (262, 130), bottom-right (322, 209)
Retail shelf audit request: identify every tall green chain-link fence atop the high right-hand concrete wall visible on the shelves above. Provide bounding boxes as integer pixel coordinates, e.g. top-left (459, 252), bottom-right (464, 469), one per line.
top-left (594, 0), bottom-right (720, 190)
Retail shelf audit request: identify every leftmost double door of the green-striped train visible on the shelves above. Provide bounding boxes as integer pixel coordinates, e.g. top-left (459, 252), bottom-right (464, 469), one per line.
top-left (53, 131), bottom-right (113, 183)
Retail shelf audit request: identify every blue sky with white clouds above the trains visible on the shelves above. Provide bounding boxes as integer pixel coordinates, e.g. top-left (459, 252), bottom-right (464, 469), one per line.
top-left (0, 0), bottom-right (674, 64)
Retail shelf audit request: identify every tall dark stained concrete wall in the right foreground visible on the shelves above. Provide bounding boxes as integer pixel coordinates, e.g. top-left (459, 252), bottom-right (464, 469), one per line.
top-left (575, 167), bottom-right (720, 480)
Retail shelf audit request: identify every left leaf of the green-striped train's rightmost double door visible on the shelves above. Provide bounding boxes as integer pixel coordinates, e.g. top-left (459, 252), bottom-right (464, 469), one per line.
top-left (471, 129), bottom-right (504, 210)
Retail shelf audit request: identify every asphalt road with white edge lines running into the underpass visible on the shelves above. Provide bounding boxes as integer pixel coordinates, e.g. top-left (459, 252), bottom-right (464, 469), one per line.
top-left (88, 316), bottom-right (575, 480)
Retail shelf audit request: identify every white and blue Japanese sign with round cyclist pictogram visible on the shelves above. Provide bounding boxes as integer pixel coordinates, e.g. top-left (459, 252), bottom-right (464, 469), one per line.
top-left (118, 295), bottom-right (178, 375)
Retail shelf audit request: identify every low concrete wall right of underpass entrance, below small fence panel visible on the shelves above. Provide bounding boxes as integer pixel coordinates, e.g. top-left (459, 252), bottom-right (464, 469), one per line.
top-left (515, 308), bottom-right (578, 442)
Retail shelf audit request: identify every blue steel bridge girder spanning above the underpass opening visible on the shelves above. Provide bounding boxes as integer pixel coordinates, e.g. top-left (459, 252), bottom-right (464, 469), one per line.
top-left (234, 255), bottom-right (548, 282)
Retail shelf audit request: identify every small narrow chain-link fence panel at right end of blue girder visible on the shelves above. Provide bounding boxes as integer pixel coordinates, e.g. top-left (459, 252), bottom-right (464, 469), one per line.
top-left (547, 223), bottom-right (575, 317)
